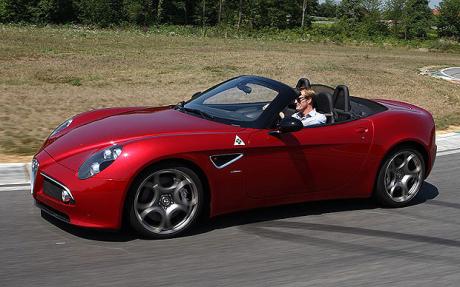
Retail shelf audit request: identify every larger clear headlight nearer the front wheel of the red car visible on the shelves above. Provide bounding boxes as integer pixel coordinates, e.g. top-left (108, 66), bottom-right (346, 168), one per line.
top-left (78, 145), bottom-right (122, 179)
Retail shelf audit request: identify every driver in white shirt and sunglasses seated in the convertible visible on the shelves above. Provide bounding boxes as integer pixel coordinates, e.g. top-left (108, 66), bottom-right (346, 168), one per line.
top-left (292, 87), bottom-right (326, 127)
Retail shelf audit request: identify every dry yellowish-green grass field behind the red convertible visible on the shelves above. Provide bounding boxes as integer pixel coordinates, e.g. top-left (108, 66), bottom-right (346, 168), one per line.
top-left (0, 25), bottom-right (460, 159)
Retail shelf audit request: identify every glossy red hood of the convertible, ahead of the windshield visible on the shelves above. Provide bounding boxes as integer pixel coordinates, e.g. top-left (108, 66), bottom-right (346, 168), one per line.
top-left (43, 107), bottom-right (240, 167)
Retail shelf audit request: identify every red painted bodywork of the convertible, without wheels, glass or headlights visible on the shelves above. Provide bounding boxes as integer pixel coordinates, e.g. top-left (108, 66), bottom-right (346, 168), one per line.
top-left (33, 90), bottom-right (436, 232)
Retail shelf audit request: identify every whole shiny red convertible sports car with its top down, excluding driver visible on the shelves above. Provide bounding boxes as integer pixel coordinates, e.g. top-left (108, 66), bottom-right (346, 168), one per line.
top-left (31, 76), bottom-right (436, 238)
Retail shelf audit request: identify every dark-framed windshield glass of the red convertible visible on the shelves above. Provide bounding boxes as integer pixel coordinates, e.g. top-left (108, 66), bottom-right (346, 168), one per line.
top-left (179, 78), bottom-right (279, 125)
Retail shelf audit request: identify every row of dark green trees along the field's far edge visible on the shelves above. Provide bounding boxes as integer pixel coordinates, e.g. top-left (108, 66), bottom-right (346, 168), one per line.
top-left (0, 0), bottom-right (460, 39)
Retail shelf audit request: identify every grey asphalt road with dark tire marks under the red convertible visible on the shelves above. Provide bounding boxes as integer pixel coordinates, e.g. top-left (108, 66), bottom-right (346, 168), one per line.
top-left (0, 154), bottom-right (460, 287)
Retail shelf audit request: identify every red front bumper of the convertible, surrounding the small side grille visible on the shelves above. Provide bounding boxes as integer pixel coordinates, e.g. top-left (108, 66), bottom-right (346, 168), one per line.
top-left (32, 151), bottom-right (128, 229)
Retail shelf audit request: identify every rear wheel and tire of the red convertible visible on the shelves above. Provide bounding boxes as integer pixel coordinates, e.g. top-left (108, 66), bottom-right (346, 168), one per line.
top-left (374, 147), bottom-right (425, 207)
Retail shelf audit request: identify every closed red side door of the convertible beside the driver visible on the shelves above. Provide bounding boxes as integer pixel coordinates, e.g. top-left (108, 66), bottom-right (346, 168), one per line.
top-left (245, 119), bottom-right (373, 198)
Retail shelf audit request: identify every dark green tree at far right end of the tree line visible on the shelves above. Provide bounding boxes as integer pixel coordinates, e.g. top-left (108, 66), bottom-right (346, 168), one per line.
top-left (438, 0), bottom-right (460, 40)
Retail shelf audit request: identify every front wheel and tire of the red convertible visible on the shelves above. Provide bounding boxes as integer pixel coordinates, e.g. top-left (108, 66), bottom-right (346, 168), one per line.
top-left (127, 163), bottom-right (205, 239)
